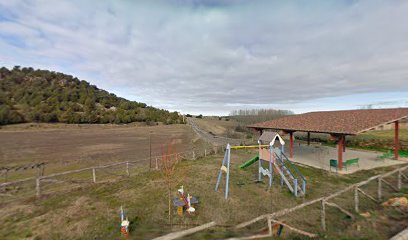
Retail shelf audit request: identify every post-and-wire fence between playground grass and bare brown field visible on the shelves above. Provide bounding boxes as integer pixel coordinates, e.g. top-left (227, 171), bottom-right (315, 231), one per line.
top-left (0, 147), bottom-right (223, 201)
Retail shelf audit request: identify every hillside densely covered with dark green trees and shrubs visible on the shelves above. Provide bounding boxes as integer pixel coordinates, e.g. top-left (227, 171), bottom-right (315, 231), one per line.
top-left (0, 66), bottom-right (182, 125)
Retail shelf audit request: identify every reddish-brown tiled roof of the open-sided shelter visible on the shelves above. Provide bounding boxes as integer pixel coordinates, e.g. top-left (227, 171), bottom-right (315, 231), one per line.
top-left (248, 108), bottom-right (408, 135)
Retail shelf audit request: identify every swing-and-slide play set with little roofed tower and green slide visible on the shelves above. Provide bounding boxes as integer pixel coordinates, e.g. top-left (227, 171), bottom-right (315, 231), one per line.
top-left (215, 132), bottom-right (306, 199)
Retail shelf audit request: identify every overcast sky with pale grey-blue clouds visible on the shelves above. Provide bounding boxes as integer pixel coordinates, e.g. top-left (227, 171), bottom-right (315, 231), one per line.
top-left (0, 0), bottom-right (408, 115)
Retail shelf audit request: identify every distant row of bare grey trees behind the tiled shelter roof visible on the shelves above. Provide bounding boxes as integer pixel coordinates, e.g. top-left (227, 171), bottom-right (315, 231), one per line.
top-left (229, 109), bottom-right (294, 125)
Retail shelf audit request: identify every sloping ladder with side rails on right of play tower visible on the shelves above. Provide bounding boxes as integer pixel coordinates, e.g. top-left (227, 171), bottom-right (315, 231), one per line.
top-left (274, 148), bottom-right (306, 197)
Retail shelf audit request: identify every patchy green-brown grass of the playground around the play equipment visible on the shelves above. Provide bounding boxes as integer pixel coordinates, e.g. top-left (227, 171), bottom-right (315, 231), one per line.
top-left (0, 147), bottom-right (408, 239)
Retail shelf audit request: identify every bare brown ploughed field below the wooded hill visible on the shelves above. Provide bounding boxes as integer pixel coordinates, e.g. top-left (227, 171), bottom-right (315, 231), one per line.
top-left (0, 124), bottom-right (194, 169)
